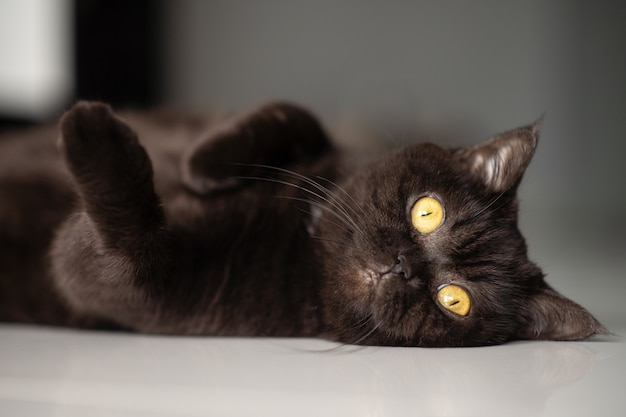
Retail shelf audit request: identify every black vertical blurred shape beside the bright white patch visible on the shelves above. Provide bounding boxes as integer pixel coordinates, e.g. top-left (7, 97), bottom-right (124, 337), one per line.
top-left (74, 0), bottom-right (163, 108)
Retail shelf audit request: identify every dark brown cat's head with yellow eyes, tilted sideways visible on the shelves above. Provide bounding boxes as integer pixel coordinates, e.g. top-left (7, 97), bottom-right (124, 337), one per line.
top-left (316, 123), bottom-right (604, 346)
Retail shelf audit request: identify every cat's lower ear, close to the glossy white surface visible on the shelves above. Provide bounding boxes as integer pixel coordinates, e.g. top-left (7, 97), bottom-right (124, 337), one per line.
top-left (518, 286), bottom-right (608, 340)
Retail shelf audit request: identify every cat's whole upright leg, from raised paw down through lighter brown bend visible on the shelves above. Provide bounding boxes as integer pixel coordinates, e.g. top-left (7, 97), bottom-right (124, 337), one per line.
top-left (51, 102), bottom-right (172, 330)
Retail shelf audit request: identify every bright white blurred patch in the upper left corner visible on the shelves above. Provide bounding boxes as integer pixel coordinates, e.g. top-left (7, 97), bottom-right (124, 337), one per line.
top-left (0, 0), bottom-right (74, 119)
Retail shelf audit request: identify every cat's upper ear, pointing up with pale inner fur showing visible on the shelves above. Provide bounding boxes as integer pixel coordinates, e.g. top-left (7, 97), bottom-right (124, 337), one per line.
top-left (456, 119), bottom-right (543, 193)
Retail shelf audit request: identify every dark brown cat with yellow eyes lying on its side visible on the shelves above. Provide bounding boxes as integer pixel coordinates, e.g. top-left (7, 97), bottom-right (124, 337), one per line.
top-left (0, 102), bottom-right (606, 347)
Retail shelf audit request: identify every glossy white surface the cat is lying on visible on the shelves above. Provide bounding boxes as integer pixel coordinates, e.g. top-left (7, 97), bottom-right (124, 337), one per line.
top-left (0, 325), bottom-right (626, 417)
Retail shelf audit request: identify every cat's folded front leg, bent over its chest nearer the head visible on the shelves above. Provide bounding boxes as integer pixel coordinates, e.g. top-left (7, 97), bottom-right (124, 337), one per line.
top-left (182, 103), bottom-right (332, 195)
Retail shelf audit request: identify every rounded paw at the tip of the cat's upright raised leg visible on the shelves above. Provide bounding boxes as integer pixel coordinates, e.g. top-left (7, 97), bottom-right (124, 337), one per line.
top-left (60, 101), bottom-right (147, 176)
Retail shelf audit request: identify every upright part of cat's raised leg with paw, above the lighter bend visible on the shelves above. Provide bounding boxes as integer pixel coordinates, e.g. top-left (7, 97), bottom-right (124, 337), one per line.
top-left (60, 102), bottom-right (165, 248)
